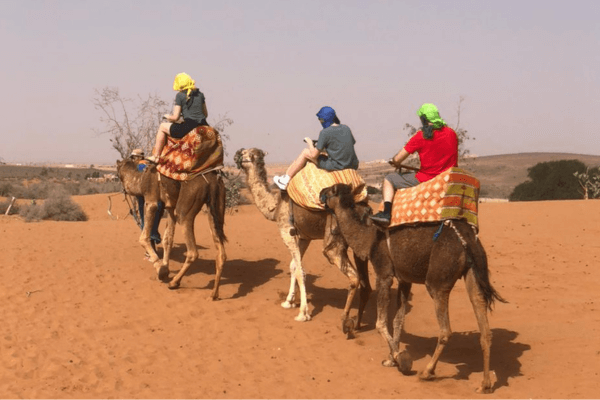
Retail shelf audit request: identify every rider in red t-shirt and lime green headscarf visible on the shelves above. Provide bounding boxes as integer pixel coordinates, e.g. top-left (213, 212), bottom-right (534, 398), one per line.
top-left (371, 103), bottom-right (458, 225)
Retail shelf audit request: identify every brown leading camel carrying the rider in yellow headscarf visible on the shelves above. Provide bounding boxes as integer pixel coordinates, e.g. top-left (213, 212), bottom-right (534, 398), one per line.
top-left (117, 159), bottom-right (227, 300)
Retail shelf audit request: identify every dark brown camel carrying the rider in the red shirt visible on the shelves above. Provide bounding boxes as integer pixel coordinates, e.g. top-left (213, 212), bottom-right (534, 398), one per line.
top-left (321, 184), bottom-right (505, 393)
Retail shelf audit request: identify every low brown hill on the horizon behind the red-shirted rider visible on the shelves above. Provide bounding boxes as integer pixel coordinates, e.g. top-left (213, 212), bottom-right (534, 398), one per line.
top-left (359, 153), bottom-right (600, 199)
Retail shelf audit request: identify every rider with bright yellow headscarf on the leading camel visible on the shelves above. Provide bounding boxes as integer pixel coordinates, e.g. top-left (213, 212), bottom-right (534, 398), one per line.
top-left (147, 72), bottom-right (208, 163)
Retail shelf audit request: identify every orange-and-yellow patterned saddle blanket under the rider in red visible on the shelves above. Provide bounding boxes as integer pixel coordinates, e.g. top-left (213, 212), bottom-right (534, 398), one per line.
top-left (380, 167), bottom-right (480, 230)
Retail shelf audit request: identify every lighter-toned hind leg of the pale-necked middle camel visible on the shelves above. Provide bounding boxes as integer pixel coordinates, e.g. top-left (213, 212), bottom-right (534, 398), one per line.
top-left (323, 216), bottom-right (360, 339)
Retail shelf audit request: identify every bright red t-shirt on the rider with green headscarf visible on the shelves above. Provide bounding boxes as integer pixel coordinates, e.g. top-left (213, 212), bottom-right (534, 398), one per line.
top-left (404, 126), bottom-right (458, 182)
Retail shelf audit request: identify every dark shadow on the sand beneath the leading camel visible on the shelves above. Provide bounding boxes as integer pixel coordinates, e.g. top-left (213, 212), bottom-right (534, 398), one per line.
top-left (164, 245), bottom-right (282, 299)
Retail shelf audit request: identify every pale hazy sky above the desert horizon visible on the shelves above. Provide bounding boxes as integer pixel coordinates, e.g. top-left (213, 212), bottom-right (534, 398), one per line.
top-left (0, 0), bottom-right (600, 164)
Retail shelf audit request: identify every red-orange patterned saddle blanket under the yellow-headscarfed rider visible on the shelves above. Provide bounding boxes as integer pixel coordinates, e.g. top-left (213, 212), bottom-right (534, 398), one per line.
top-left (156, 125), bottom-right (223, 181)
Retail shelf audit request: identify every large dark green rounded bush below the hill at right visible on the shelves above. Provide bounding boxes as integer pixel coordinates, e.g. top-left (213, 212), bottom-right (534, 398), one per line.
top-left (509, 160), bottom-right (586, 201)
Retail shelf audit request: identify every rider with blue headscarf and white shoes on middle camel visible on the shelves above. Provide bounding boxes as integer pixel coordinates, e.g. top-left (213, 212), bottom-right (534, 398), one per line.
top-left (273, 107), bottom-right (358, 190)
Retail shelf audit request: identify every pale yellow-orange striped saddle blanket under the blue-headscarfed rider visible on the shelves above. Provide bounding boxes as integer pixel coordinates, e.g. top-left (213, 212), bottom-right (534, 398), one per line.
top-left (287, 162), bottom-right (367, 210)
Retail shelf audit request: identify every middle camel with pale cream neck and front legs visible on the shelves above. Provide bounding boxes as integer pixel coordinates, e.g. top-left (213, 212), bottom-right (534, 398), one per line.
top-left (234, 148), bottom-right (372, 337)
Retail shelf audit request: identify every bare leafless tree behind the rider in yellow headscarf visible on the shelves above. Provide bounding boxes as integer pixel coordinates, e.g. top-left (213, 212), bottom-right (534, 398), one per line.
top-left (92, 87), bottom-right (233, 158)
